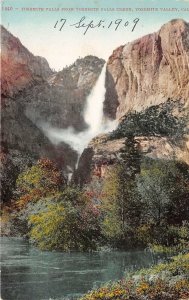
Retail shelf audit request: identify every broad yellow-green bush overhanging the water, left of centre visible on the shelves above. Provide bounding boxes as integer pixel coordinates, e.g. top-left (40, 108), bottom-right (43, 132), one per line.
top-left (29, 187), bottom-right (100, 251)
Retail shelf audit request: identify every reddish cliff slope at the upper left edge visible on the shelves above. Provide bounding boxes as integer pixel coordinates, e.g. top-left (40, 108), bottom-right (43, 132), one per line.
top-left (1, 26), bottom-right (53, 97)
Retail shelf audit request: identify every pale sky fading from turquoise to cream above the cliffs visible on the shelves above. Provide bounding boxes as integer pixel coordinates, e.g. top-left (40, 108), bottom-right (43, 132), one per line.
top-left (0, 0), bottom-right (189, 71)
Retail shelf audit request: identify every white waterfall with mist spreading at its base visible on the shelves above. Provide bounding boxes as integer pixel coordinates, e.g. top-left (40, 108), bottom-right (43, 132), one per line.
top-left (41, 65), bottom-right (117, 157)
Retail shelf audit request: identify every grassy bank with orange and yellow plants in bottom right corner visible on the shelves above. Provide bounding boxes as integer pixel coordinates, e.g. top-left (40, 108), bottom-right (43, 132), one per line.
top-left (81, 253), bottom-right (189, 300)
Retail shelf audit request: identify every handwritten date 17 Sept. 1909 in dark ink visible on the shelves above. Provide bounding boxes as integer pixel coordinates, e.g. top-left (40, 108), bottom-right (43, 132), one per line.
top-left (54, 17), bottom-right (140, 35)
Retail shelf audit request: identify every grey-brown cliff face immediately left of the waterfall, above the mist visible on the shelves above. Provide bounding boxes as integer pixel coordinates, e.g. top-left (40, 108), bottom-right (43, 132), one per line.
top-left (19, 56), bottom-right (105, 131)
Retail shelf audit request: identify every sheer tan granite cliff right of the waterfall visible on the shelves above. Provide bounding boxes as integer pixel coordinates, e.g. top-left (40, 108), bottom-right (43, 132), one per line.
top-left (104, 20), bottom-right (189, 118)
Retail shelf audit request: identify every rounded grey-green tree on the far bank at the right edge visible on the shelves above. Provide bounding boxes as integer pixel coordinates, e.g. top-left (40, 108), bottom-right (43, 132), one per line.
top-left (136, 160), bottom-right (189, 248)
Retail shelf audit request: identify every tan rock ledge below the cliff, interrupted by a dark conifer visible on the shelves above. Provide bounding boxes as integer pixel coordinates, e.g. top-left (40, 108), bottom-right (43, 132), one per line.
top-left (74, 129), bottom-right (189, 185)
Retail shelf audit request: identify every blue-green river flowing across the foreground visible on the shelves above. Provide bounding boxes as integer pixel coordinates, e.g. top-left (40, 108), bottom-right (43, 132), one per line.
top-left (1, 237), bottom-right (162, 300)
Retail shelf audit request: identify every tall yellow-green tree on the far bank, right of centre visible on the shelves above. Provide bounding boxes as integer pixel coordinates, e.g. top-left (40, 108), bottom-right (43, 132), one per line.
top-left (102, 165), bottom-right (140, 247)
